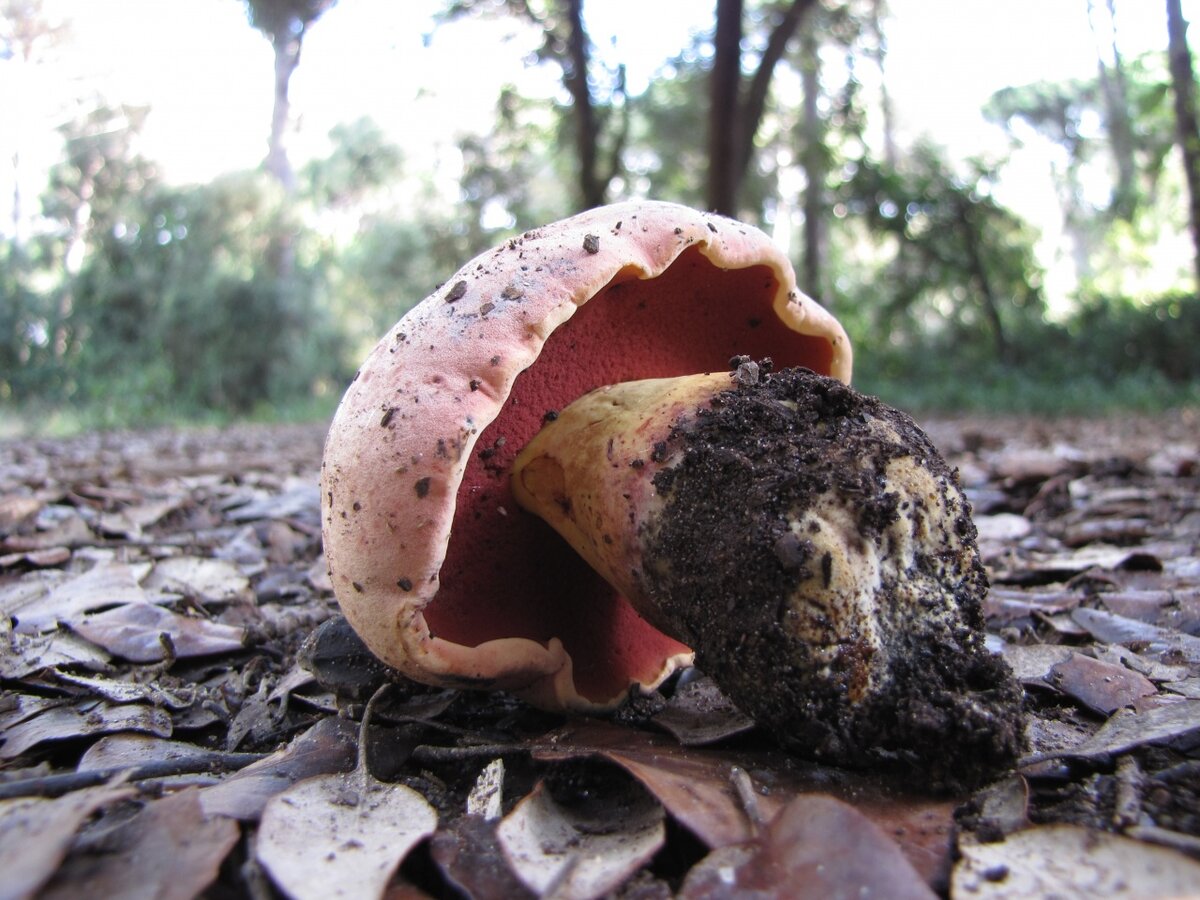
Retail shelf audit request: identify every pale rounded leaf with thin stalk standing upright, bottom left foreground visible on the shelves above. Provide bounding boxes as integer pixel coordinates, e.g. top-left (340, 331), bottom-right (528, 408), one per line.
top-left (256, 768), bottom-right (438, 900)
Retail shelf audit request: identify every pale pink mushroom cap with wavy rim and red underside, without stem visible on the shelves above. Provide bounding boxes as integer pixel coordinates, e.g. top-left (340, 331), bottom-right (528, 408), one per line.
top-left (322, 202), bottom-right (1022, 787)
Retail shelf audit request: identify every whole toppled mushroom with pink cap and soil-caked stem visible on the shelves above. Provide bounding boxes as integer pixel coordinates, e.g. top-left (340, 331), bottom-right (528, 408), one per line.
top-left (322, 202), bottom-right (1020, 778)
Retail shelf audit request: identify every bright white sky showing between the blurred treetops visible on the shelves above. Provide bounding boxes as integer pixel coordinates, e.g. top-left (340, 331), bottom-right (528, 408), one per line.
top-left (0, 0), bottom-right (1200, 236)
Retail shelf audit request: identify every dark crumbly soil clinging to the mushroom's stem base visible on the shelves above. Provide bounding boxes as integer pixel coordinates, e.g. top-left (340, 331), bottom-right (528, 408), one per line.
top-left (646, 360), bottom-right (1021, 788)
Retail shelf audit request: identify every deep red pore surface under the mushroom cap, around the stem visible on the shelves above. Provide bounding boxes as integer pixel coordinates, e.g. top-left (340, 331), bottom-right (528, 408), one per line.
top-left (424, 248), bottom-right (832, 702)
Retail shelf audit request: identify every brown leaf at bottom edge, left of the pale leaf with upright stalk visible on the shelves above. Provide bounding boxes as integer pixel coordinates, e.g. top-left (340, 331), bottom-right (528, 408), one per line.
top-left (40, 788), bottom-right (241, 900)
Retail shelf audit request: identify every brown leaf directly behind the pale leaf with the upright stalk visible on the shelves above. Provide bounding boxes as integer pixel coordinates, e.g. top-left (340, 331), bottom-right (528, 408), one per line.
top-left (200, 716), bottom-right (358, 821)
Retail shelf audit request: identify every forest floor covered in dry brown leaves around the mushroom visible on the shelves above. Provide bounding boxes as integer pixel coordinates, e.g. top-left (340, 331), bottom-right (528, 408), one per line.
top-left (0, 412), bottom-right (1200, 898)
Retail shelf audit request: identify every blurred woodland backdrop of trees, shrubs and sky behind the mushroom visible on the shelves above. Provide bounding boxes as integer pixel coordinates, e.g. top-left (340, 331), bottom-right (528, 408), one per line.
top-left (0, 0), bottom-right (1200, 437)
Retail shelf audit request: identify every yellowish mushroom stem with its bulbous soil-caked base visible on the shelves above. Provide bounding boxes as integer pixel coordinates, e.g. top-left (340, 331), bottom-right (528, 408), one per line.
top-left (512, 358), bottom-right (1021, 785)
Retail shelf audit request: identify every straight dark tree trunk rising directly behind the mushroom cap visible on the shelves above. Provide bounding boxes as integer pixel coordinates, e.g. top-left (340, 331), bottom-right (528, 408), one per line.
top-left (707, 0), bottom-right (742, 216)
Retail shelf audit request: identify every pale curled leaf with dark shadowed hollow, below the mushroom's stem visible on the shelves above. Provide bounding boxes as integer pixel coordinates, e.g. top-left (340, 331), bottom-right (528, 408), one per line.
top-left (496, 784), bottom-right (666, 900)
